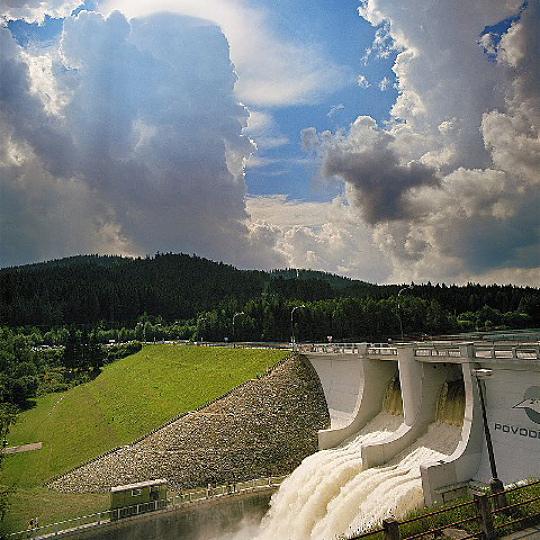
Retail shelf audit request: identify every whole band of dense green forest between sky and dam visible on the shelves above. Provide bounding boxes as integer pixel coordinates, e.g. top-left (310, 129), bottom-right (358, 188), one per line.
top-left (0, 254), bottom-right (540, 343)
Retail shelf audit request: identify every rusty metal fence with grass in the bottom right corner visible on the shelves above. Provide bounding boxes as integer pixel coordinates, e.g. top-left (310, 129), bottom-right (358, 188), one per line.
top-left (347, 481), bottom-right (540, 540)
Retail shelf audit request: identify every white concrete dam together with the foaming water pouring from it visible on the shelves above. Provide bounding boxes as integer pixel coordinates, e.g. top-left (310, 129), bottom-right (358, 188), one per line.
top-left (43, 342), bottom-right (540, 540)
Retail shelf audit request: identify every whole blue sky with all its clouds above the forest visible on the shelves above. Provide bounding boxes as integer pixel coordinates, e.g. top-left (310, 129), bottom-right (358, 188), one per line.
top-left (0, 0), bottom-right (540, 286)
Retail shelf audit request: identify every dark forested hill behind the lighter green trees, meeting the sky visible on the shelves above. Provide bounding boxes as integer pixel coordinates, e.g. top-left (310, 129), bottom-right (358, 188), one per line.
top-left (0, 254), bottom-right (540, 332)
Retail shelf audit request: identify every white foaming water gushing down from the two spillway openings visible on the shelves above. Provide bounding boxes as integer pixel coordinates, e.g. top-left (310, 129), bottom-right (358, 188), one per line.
top-left (251, 422), bottom-right (461, 540)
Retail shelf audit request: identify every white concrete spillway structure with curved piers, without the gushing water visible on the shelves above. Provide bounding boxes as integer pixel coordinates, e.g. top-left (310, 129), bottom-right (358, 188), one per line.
top-left (301, 342), bottom-right (540, 505)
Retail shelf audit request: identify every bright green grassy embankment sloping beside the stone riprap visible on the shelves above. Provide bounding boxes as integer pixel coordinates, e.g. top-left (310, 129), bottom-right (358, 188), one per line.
top-left (2, 345), bottom-right (287, 530)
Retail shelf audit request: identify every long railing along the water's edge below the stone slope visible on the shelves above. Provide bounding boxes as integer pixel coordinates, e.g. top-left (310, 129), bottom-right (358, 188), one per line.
top-left (8, 476), bottom-right (286, 540)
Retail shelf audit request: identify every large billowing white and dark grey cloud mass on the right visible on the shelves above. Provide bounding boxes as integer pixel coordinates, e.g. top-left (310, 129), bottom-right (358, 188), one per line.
top-left (305, 0), bottom-right (540, 285)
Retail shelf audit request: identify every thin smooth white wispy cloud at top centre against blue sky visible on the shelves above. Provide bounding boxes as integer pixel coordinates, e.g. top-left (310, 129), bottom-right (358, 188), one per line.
top-left (100, 0), bottom-right (352, 106)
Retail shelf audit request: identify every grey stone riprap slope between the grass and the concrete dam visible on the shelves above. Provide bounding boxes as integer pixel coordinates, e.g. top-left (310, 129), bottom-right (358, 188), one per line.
top-left (49, 356), bottom-right (330, 493)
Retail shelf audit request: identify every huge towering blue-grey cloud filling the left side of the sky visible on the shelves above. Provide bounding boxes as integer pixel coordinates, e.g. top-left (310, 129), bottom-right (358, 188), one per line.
top-left (0, 12), bottom-right (282, 265)
